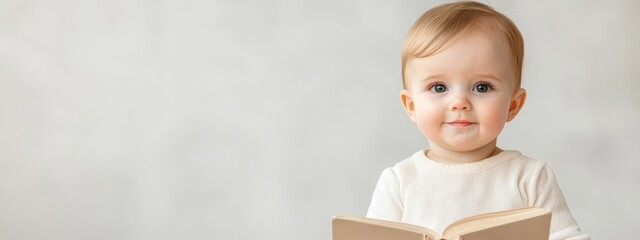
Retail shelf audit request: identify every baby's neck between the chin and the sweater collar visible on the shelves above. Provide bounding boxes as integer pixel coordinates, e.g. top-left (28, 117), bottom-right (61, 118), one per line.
top-left (426, 141), bottom-right (502, 163)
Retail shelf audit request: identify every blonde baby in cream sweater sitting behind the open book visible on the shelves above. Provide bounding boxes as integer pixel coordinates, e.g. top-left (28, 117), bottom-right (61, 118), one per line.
top-left (367, 2), bottom-right (590, 239)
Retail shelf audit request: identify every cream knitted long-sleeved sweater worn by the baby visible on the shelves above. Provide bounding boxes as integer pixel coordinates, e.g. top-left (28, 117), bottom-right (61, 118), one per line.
top-left (367, 151), bottom-right (590, 240)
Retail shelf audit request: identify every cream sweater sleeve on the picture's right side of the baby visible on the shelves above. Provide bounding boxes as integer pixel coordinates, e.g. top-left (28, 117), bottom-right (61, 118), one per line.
top-left (533, 164), bottom-right (591, 240)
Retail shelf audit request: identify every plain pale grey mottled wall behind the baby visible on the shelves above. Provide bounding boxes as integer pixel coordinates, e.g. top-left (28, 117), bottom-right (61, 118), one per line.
top-left (0, 0), bottom-right (640, 240)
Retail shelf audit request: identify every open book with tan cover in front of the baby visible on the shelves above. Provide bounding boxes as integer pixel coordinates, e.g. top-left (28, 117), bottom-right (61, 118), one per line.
top-left (331, 207), bottom-right (551, 240)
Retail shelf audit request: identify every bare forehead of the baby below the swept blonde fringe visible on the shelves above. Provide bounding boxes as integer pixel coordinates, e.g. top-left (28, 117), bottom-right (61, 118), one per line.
top-left (406, 29), bottom-right (515, 82)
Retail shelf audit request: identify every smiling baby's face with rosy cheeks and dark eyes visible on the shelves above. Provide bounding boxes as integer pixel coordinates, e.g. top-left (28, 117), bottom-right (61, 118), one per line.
top-left (402, 31), bottom-right (524, 156)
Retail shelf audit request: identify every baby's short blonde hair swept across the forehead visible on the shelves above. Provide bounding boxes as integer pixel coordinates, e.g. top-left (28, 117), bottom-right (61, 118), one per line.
top-left (402, 1), bottom-right (524, 89)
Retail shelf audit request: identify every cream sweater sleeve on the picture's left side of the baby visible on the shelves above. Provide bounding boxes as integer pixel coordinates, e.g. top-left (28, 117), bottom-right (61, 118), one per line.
top-left (367, 168), bottom-right (403, 221)
